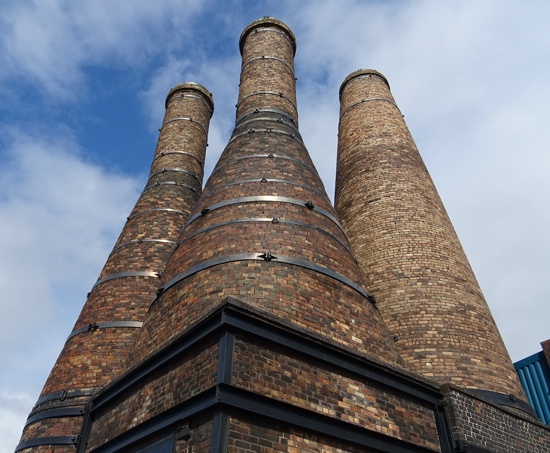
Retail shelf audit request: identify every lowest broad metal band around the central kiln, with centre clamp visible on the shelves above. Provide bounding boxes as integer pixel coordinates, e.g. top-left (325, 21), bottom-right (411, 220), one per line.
top-left (152, 252), bottom-right (375, 304)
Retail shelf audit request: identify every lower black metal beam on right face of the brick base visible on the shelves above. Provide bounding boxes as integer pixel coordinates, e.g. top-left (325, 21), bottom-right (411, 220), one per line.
top-left (218, 385), bottom-right (439, 453)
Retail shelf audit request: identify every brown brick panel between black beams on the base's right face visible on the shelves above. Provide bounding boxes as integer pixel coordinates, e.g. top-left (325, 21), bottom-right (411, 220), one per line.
top-left (233, 334), bottom-right (439, 450)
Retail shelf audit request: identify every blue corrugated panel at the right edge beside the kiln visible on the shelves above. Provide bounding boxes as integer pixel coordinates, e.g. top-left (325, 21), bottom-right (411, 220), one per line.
top-left (514, 352), bottom-right (550, 424)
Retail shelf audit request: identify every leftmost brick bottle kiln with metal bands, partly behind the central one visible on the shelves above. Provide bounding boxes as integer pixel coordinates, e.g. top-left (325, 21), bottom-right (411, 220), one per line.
top-left (18, 83), bottom-right (213, 452)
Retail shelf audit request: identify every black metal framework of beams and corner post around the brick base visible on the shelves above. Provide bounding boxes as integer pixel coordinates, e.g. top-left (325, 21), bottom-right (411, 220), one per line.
top-left (83, 298), bottom-right (448, 453)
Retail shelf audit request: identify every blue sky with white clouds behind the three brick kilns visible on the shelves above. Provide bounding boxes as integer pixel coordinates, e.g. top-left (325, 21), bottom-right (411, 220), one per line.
top-left (0, 0), bottom-right (550, 453)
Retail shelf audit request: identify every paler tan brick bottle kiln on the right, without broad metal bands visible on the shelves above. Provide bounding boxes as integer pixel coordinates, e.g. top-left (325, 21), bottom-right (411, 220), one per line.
top-left (335, 70), bottom-right (525, 399)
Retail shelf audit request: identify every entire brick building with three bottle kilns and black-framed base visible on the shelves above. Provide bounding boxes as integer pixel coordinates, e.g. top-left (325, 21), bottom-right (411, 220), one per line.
top-left (16, 18), bottom-right (550, 453)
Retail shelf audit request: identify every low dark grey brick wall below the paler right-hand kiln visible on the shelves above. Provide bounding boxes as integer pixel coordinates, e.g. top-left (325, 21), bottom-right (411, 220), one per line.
top-left (445, 388), bottom-right (550, 453)
